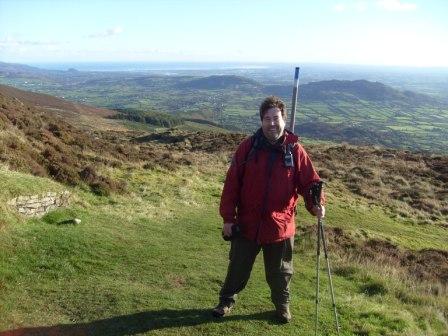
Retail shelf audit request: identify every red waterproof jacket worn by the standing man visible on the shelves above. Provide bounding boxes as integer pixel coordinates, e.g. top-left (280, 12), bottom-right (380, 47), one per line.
top-left (220, 130), bottom-right (320, 244)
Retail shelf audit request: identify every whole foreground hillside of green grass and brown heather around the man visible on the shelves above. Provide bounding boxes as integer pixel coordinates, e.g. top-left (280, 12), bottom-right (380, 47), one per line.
top-left (0, 85), bottom-right (448, 336)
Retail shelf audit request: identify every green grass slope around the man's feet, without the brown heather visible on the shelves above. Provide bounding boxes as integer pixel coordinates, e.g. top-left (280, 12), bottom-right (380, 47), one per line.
top-left (0, 162), bottom-right (448, 335)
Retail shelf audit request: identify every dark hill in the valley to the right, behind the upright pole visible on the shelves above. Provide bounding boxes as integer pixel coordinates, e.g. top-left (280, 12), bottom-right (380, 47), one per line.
top-left (263, 80), bottom-right (441, 106)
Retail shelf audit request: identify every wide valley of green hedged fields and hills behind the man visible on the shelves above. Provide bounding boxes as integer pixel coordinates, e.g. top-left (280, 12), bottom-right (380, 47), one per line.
top-left (0, 61), bottom-right (448, 154)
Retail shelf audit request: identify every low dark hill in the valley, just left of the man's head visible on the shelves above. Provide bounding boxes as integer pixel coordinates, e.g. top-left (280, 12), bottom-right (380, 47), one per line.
top-left (177, 75), bottom-right (261, 90)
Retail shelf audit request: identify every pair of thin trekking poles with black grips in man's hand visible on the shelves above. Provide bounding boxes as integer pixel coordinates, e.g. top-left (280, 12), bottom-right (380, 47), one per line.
top-left (310, 181), bottom-right (340, 336)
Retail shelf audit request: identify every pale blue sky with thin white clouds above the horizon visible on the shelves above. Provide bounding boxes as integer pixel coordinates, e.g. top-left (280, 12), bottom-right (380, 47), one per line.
top-left (0, 0), bottom-right (448, 67)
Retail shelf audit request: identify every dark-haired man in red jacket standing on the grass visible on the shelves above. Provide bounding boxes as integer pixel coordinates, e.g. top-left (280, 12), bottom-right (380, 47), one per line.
top-left (212, 96), bottom-right (325, 323)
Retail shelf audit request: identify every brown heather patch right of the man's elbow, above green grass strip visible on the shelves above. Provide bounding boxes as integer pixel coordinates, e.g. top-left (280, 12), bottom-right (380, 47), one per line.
top-left (307, 144), bottom-right (448, 222)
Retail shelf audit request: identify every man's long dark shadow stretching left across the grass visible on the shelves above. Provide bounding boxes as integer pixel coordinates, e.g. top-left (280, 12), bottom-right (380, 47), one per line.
top-left (0, 309), bottom-right (277, 336)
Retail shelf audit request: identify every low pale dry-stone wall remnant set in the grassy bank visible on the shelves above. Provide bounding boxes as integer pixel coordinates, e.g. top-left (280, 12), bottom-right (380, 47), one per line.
top-left (8, 191), bottom-right (70, 217)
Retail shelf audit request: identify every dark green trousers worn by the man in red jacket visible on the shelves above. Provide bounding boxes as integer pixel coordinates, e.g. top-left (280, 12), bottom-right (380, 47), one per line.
top-left (219, 237), bottom-right (294, 307)
